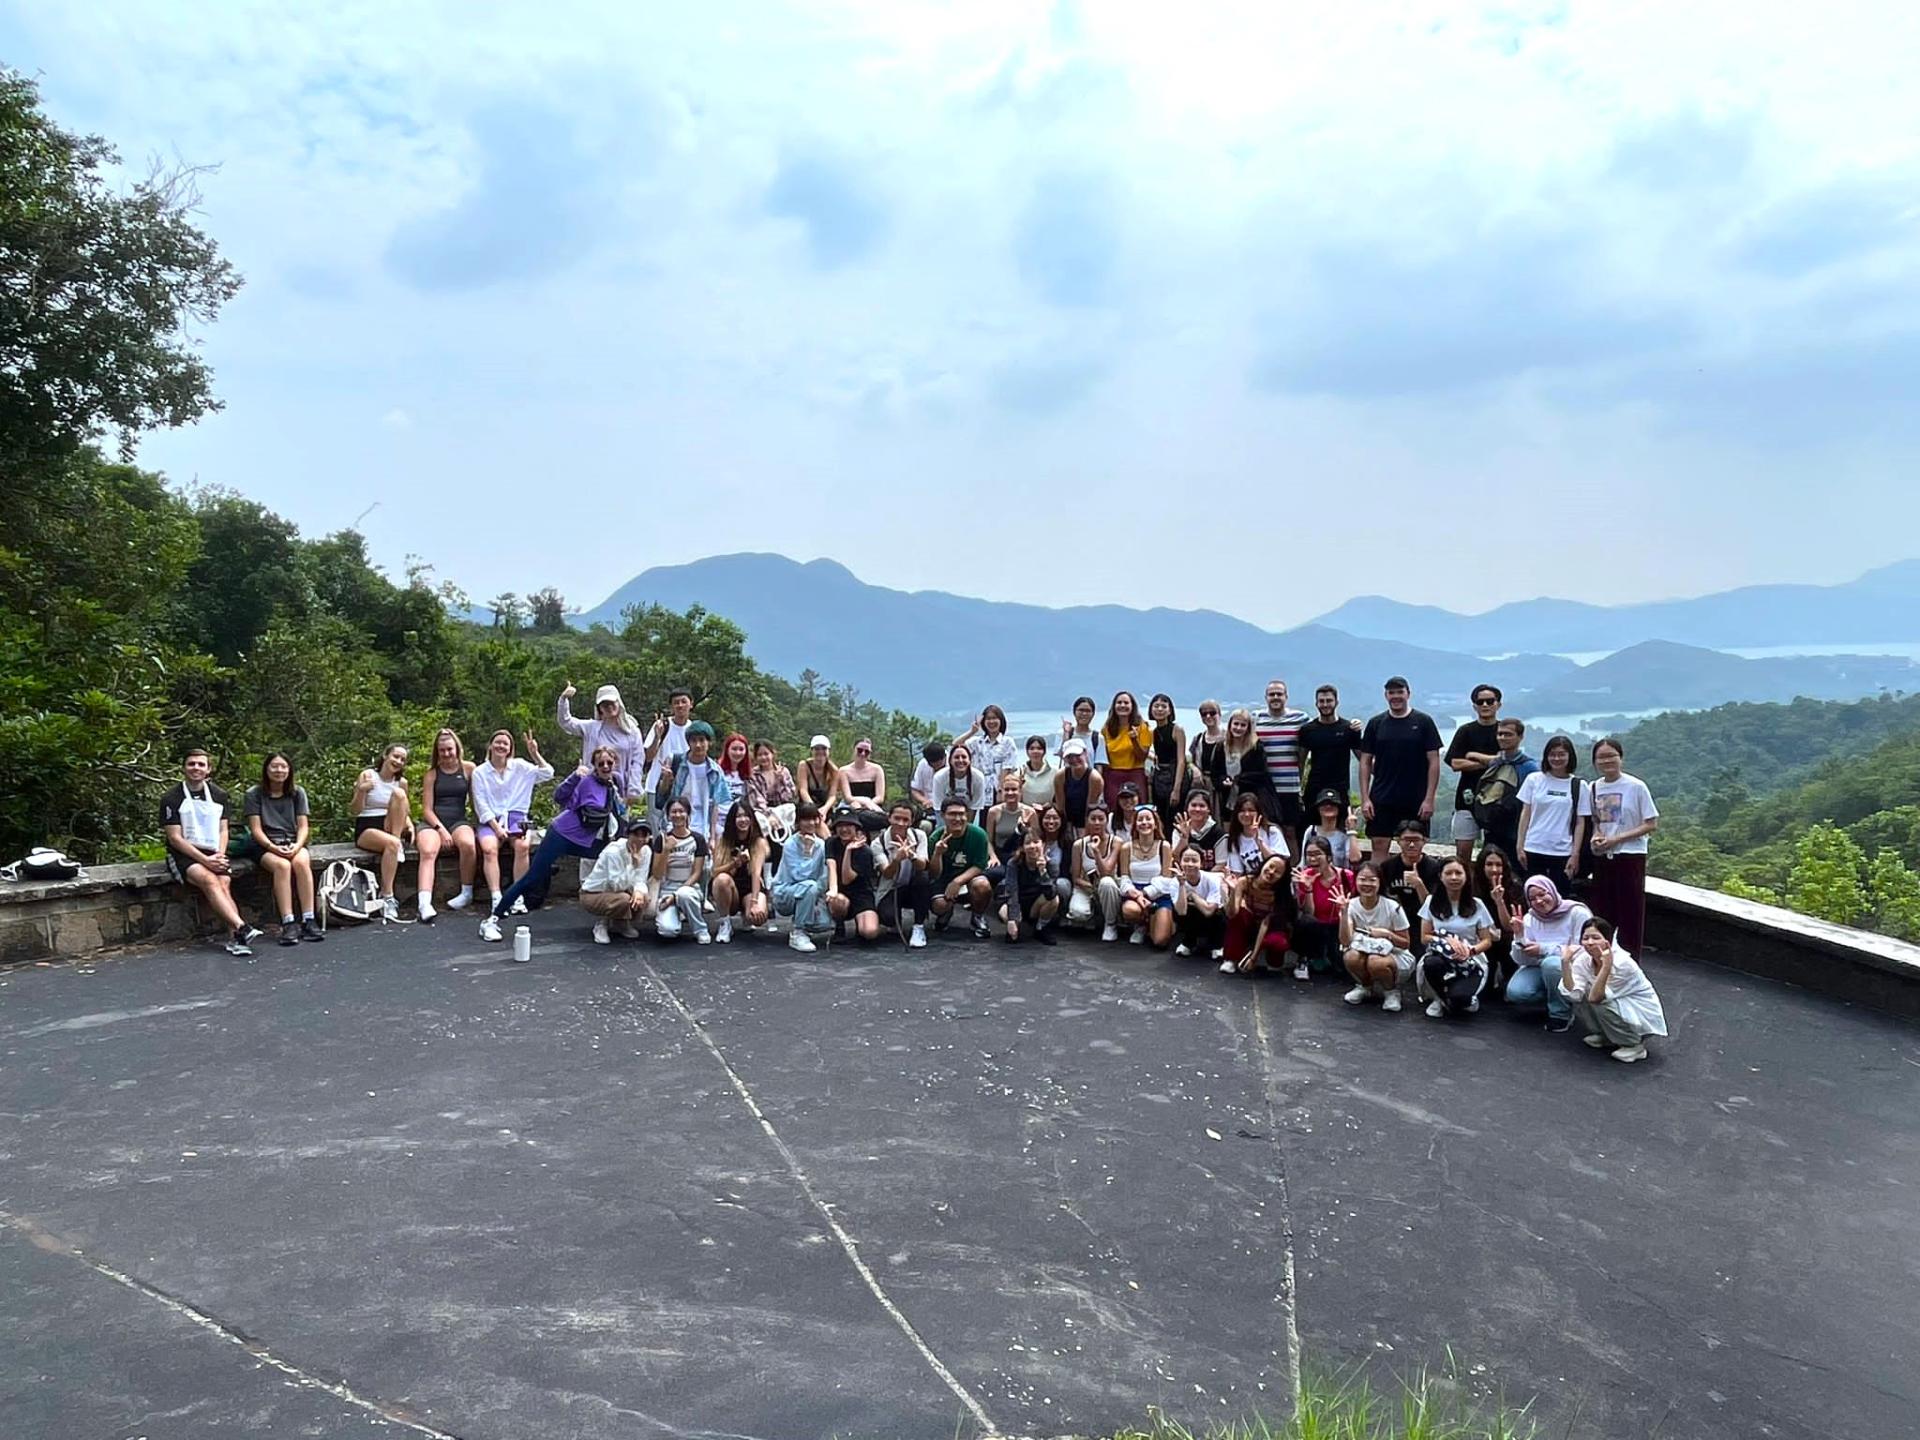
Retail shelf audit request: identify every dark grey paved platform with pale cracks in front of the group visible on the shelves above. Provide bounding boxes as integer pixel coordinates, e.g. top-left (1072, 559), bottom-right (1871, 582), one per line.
top-left (0, 908), bottom-right (1920, 1440)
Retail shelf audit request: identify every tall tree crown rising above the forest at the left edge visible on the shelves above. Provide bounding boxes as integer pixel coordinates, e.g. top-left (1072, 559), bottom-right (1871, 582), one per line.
top-left (0, 71), bottom-right (240, 472)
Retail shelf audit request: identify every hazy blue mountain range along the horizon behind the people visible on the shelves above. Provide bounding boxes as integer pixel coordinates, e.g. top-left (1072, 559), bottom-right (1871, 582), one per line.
top-left (560, 555), bottom-right (1920, 714)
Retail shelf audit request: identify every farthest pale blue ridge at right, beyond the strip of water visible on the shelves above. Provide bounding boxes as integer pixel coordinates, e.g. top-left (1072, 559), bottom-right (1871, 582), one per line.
top-left (1317, 561), bottom-right (1920, 655)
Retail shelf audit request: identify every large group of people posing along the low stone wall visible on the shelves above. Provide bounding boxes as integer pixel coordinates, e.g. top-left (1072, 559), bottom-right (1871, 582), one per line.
top-left (161, 676), bottom-right (1667, 1062)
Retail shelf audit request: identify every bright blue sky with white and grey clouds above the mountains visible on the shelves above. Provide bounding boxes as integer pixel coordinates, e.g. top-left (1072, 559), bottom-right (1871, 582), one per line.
top-left (0, 0), bottom-right (1920, 628)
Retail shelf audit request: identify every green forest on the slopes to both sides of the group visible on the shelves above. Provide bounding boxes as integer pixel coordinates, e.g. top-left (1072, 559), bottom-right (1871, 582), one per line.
top-left (0, 71), bottom-right (1920, 939)
